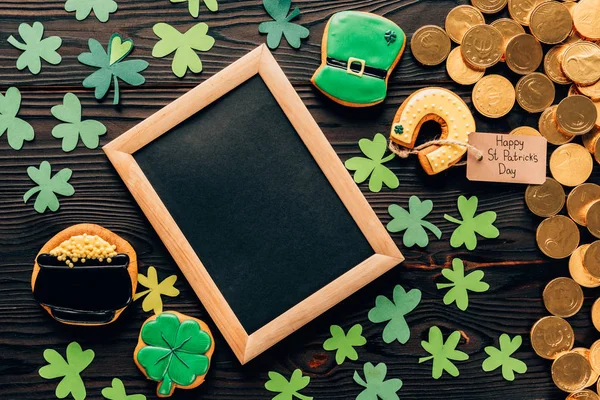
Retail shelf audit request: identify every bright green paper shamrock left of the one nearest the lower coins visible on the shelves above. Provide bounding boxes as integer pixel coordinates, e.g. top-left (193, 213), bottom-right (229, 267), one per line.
top-left (419, 326), bottom-right (469, 379)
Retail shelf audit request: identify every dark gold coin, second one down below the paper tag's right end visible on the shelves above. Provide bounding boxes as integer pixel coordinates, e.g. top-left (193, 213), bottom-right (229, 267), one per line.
top-left (535, 215), bottom-right (579, 259)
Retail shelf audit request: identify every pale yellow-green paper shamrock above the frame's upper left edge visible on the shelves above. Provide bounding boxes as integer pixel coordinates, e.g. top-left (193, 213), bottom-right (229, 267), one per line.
top-left (152, 22), bottom-right (215, 78)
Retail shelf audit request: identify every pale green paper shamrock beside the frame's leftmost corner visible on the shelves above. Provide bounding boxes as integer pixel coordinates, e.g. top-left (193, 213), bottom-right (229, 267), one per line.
top-left (50, 93), bottom-right (106, 152)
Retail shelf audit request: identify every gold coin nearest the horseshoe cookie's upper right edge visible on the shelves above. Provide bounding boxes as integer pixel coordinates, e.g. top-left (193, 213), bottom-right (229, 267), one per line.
top-left (473, 75), bottom-right (515, 118)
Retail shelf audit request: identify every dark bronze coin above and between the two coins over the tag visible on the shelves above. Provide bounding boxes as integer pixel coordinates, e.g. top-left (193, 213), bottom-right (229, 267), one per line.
top-left (506, 33), bottom-right (544, 75)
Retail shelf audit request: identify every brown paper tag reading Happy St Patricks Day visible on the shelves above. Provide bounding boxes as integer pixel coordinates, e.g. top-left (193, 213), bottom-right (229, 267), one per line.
top-left (467, 132), bottom-right (548, 185)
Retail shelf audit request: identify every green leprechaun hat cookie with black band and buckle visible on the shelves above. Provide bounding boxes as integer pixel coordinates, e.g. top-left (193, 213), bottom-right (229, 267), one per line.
top-left (311, 11), bottom-right (406, 107)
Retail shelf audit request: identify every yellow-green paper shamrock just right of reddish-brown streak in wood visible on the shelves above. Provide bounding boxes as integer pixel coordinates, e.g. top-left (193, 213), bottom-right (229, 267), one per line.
top-left (437, 258), bottom-right (490, 311)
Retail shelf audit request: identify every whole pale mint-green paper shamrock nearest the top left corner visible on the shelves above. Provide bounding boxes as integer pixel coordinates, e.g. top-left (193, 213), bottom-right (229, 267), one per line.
top-left (8, 22), bottom-right (62, 75)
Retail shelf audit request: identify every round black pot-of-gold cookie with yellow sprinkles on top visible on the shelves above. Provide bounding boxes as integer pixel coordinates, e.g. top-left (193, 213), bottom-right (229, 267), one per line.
top-left (31, 224), bottom-right (138, 325)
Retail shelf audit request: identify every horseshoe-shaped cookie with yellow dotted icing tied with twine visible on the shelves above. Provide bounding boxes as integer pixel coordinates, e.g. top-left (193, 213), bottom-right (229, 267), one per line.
top-left (390, 87), bottom-right (476, 175)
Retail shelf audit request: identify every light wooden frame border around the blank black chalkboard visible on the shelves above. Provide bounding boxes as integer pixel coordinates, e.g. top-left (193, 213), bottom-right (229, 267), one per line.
top-left (104, 45), bottom-right (404, 364)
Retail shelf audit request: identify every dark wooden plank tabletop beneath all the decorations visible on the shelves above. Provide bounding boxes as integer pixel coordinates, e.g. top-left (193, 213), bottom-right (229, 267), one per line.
top-left (0, 0), bottom-right (600, 400)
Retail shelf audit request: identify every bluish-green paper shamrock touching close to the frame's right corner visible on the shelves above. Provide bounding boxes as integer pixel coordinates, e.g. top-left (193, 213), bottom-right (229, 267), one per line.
top-left (387, 196), bottom-right (442, 247)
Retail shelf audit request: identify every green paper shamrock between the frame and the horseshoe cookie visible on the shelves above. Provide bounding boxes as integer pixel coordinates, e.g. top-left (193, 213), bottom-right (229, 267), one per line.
top-left (344, 133), bottom-right (400, 192)
